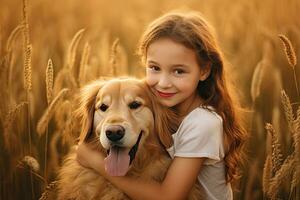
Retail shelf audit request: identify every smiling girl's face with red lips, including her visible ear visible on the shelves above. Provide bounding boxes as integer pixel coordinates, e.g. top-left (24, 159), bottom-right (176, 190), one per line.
top-left (146, 38), bottom-right (209, 112)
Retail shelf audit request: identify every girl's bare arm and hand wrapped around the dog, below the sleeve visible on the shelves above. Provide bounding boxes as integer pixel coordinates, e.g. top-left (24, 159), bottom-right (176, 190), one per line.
top-left (77, 143), bottom-right (205, 200)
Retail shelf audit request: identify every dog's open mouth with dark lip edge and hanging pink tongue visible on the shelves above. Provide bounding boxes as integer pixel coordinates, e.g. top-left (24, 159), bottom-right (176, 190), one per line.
top-left (104, 131), bottom-right (143, 176)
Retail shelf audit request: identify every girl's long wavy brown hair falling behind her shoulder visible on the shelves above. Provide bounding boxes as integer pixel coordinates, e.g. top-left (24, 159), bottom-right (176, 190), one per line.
top-left (139, 12), bottom-right (247, 185)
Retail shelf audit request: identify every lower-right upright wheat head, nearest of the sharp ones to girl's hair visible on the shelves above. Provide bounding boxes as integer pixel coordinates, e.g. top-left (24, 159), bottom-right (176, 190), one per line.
top-left (265, 123), bottom-right (282, 173)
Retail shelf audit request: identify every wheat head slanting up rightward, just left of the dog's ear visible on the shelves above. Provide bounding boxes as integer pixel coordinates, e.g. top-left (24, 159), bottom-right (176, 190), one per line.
top-left (37, 88), bottom-right (69, 136)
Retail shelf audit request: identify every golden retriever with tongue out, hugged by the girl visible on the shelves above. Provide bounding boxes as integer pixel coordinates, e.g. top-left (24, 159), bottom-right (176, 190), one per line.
top-left (58, 78), bottom-right (200, 200)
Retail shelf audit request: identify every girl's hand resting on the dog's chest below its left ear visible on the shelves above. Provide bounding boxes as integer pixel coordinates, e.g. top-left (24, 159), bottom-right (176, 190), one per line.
top-left (76, 142), bottom-right (104, 174)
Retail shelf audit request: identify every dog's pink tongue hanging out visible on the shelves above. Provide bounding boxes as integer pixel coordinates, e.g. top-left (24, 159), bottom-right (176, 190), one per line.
top-left (104, 147), bottom-right (130, 176)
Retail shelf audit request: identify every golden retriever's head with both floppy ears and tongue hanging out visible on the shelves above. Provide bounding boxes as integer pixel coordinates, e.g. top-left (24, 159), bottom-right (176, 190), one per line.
top-left (78, 78), bottom-right (177, 176)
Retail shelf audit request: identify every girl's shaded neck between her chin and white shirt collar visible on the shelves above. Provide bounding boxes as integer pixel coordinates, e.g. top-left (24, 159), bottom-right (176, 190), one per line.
top-left (175, 94), bottom-right (203, 120)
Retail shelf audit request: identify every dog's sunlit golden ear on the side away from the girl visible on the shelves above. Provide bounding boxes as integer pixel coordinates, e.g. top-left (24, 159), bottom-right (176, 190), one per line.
top-left (75, 80), bottom-right (105, 142)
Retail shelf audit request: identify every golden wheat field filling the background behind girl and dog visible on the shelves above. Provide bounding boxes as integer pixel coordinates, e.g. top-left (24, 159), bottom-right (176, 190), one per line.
top-left (0, 0), bottom-right (300, 200)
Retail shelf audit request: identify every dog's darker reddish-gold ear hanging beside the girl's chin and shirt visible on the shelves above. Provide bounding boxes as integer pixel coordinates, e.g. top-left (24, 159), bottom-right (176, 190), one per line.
top-left (144, 82), bottom-right (179, 148)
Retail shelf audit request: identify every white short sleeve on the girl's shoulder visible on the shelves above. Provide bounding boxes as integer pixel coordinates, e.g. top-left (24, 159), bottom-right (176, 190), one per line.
top-left (174, 109), bottom-right (224, 165)
